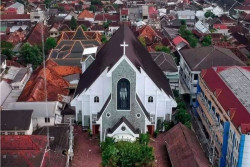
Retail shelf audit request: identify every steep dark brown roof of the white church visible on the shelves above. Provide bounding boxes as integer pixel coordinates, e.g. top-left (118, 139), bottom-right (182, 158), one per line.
top-left (74, 25), bottom-right (172, 96)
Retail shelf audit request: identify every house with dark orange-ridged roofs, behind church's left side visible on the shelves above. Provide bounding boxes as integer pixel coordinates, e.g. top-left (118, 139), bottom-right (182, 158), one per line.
top-left (49, 26), bottom-right (101, 67)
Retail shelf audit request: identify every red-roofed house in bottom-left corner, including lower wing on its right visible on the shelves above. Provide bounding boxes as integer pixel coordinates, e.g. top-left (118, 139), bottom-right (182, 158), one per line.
top-left (1, 135), bottom-right (66, 167)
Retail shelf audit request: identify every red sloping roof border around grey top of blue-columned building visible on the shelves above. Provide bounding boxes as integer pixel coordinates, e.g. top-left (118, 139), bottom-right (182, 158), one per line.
top-left (201, 66), bottom-right (250, 132)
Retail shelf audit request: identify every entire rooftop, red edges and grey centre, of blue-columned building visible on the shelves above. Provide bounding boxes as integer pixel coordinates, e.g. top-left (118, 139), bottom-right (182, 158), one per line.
top-left (201, 66), bottom-right (250, 132)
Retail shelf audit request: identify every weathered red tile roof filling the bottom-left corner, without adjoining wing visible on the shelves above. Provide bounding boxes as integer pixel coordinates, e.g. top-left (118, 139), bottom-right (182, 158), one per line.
top-left (0, 135), bottom-right (47, 167)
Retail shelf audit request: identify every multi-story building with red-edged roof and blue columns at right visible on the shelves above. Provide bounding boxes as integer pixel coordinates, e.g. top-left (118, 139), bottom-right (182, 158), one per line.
top-left (196, 66), bottom-right (250, 167)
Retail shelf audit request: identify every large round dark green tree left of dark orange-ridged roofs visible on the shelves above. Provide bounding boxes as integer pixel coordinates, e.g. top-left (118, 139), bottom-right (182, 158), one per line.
top-left (20, 43), bottom-right (43, 69)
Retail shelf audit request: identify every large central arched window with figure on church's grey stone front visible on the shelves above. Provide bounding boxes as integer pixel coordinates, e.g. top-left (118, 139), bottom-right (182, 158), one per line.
top-left (117, 78), bottom-right (130, 110)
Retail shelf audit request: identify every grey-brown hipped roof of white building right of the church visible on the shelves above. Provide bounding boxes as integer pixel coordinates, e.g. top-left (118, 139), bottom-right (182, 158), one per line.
top-left (180, 46), bottom-right (245, 71)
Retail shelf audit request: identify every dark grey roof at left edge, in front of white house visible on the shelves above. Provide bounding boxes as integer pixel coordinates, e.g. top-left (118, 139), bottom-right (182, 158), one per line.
top-left (1, 110), bottom-right (33, 131)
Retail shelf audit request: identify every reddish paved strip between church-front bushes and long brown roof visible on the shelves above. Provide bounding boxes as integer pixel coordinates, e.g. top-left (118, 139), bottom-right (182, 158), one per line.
top-left (150, 133), bottom-right (171, 167)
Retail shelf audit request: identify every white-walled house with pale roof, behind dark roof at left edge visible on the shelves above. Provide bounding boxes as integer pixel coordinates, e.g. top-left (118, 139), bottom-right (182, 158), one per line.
top-left (6, 101), bottom-right (63, 130)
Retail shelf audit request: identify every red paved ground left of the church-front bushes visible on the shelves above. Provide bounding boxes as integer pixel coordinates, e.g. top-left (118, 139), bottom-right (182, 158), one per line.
top-left (70, 126), bottom-right (102, 167)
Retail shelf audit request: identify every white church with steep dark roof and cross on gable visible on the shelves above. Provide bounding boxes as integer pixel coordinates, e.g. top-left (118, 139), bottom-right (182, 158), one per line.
top-left (71, 25), bottom-right (177, 141)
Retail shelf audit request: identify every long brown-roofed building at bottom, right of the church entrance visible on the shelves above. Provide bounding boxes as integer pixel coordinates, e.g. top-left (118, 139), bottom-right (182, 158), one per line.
top-left (164, 123), bottom-right (211, 167)
